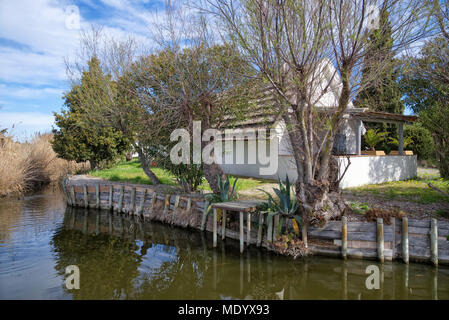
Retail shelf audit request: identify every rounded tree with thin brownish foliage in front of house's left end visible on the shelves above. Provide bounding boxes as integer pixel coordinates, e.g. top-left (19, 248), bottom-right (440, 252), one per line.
top-left (138, 1), bottom-right (253, 193)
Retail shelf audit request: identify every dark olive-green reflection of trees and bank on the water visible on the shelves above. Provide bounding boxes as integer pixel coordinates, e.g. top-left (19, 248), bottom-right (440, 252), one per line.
top-left (52, 208), bottom-right (449, 299)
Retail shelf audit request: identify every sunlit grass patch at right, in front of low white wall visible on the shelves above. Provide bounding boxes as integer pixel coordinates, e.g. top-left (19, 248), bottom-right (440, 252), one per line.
top-left (347, 174), bottom-right (449, 203)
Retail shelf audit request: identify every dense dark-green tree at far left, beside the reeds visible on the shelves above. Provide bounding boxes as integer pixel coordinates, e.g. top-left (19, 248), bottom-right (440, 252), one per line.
top-left (52, 57), bottom-right (129, 168)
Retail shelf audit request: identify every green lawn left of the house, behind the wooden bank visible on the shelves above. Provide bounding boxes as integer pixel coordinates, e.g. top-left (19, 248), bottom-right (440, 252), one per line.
top-left (89, 159), bottom-right (268, 191)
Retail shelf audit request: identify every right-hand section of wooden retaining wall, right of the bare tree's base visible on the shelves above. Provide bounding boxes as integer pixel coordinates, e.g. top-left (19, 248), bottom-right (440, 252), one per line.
top-left (307, 218), bottom-right (449, 265)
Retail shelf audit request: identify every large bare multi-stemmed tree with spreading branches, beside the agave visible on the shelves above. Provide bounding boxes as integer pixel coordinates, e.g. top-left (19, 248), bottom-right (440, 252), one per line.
top-left (207, 0), bottom-right (423, 245)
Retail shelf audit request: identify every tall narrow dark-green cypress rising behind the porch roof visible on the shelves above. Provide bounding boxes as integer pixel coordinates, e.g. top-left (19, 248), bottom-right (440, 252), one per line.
top-left (355, 10), bottom-right (404, 151)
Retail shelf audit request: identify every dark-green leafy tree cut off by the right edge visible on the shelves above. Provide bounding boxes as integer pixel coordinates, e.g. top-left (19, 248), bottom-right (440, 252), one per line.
top-left (402, 37), bottom-right (449, 179)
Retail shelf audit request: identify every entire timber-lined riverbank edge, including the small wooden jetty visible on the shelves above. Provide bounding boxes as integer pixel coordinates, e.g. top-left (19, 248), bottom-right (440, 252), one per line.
top-left (63, 178), bottom-right (449, 265)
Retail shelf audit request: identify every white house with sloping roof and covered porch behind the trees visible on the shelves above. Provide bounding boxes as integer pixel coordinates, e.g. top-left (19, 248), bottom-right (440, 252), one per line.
top-left (214, 62), bottom-right (417, 188)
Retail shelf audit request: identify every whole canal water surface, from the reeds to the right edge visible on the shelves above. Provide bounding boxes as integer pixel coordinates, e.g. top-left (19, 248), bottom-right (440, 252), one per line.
top-left (0, 188), bottom-right (449, 299)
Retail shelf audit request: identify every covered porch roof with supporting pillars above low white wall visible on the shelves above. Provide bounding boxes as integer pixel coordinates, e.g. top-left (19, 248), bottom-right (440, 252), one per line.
top-left (346, 108), bottom-right (418, 155)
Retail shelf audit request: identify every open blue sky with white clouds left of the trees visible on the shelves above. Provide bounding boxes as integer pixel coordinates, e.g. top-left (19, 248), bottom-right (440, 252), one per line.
top-left (0, 0), bottom-right (164, 140)
